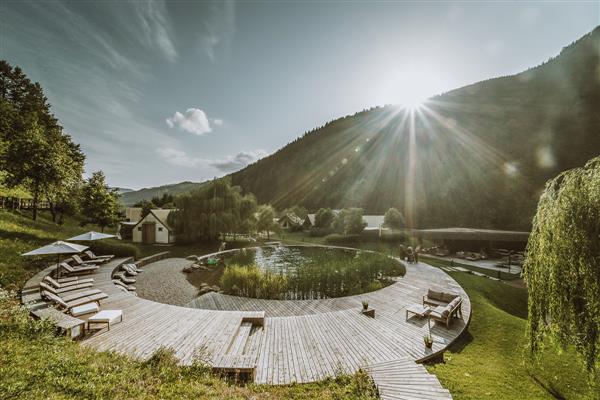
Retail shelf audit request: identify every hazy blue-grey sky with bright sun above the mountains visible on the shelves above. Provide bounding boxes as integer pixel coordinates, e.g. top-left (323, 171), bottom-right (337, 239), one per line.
top-left (0, 0), bottom-right (600, 189)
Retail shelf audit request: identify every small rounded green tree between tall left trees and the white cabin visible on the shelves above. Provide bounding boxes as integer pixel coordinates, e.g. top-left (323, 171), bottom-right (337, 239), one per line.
top-left (81, 171), bottom-right (119, 232)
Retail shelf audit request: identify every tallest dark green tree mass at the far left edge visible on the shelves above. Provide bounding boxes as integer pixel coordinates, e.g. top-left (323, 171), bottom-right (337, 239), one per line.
top-left (0, 60), bottom-right (85, 221)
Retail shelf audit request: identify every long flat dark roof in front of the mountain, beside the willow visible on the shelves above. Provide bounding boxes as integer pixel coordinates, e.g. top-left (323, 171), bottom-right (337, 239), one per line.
top-left (415, 228), bottom-right (529, 242)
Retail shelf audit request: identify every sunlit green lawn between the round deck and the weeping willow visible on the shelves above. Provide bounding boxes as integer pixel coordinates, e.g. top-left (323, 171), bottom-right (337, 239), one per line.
top-left (428, 272), bottom-right (600, 399)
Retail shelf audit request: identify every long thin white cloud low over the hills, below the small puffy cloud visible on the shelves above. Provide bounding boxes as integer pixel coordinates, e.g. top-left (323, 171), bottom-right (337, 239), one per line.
top-left (156, 147), bottom-right (268, 173)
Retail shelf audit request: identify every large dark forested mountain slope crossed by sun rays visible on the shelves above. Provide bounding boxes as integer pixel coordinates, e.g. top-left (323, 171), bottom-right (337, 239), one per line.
top-left (231, 27), bottom-right (600, 229)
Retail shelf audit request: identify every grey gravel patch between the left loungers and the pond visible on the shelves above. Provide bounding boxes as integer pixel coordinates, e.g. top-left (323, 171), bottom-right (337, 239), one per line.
top-left (135, 258), bottom-right (198, 306)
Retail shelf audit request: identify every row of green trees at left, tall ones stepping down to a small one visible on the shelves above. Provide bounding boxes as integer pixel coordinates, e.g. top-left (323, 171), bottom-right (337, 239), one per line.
top-left (0, 60), bottom-right (118, 229)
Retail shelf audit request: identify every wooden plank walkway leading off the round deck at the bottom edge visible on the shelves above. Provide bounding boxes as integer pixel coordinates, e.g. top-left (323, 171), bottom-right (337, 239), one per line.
top-left (364, 357), bottom-right (452, 400)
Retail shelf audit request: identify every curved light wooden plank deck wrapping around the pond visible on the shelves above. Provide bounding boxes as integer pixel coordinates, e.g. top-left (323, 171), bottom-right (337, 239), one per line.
top-left (24, 255), bottom-right (471, 398)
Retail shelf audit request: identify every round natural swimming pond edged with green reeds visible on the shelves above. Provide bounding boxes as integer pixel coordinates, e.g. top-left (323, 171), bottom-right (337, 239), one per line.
top-left (188, 246), bottom-right (405, 300)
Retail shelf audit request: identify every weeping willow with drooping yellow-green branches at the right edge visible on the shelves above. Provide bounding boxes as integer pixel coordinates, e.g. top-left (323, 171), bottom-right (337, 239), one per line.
top-left (523, 157), bottom-right (600, 371)
